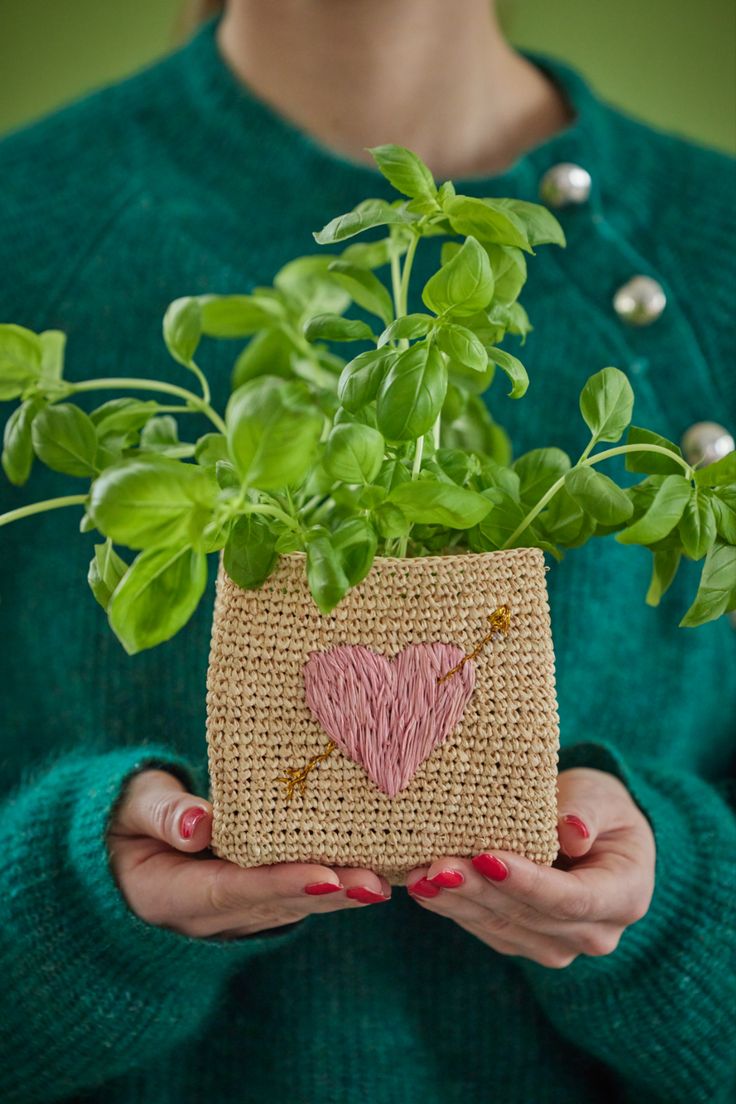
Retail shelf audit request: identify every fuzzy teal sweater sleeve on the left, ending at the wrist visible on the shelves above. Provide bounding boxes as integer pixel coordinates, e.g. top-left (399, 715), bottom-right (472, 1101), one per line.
top-left (0, 746), bottom-right (301, 1104)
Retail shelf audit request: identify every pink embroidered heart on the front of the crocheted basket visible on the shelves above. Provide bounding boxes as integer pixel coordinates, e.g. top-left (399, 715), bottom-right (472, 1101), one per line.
top-left (305, 643), bottom-right (476, 797)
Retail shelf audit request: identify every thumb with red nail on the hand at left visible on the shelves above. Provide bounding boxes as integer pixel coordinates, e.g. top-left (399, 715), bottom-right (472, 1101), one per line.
top-left (110, 771), bottom-right (212, 852)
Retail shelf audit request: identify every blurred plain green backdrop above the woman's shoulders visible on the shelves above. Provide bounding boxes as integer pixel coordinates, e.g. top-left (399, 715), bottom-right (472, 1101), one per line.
top-left (0, 0), bottom-right (736, 152)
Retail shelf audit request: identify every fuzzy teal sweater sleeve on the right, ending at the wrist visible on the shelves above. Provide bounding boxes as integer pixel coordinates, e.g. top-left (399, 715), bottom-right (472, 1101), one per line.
top-left (522, 744), bottom-right (736, 1104)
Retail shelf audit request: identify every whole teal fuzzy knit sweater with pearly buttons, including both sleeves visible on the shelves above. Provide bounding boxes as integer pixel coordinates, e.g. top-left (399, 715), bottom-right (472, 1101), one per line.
top-left (0, 17), bottom-right (736, 1104)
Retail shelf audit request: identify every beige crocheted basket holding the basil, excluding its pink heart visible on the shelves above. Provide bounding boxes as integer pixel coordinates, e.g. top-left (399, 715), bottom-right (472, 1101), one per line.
top-left (207, 549), bottom-right (558, 884)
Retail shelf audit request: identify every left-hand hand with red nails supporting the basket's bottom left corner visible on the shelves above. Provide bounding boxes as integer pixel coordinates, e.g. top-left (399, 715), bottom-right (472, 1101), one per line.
top-left (108, 771), bottom-right (391, 937)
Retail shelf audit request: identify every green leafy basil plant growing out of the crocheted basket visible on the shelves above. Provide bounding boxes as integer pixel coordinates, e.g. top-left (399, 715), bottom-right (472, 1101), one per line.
top-left (0, 146), bottom-right (736, 654)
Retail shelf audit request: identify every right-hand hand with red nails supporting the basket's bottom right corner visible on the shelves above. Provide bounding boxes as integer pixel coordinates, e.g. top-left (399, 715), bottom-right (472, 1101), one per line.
top-left (407, 768), bottom-right (654, 968)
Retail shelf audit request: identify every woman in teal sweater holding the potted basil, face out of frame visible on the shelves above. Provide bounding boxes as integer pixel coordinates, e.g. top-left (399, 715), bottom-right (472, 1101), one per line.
top-left (0, 0), bottom-right (736, 1104)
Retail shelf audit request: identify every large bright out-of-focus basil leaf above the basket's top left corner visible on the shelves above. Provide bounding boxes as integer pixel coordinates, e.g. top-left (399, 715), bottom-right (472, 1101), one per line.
top-left (225, 375), bottom-right (324, 490)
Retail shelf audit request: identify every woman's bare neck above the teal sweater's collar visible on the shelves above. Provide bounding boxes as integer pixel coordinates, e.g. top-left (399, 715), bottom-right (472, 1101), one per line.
top-left (218, 0), bottom-right (570, 177)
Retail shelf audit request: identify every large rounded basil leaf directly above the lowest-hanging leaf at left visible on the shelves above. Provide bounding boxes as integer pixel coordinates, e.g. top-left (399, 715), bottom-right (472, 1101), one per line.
top-left (88, 456), bottom-right (217, 549)
